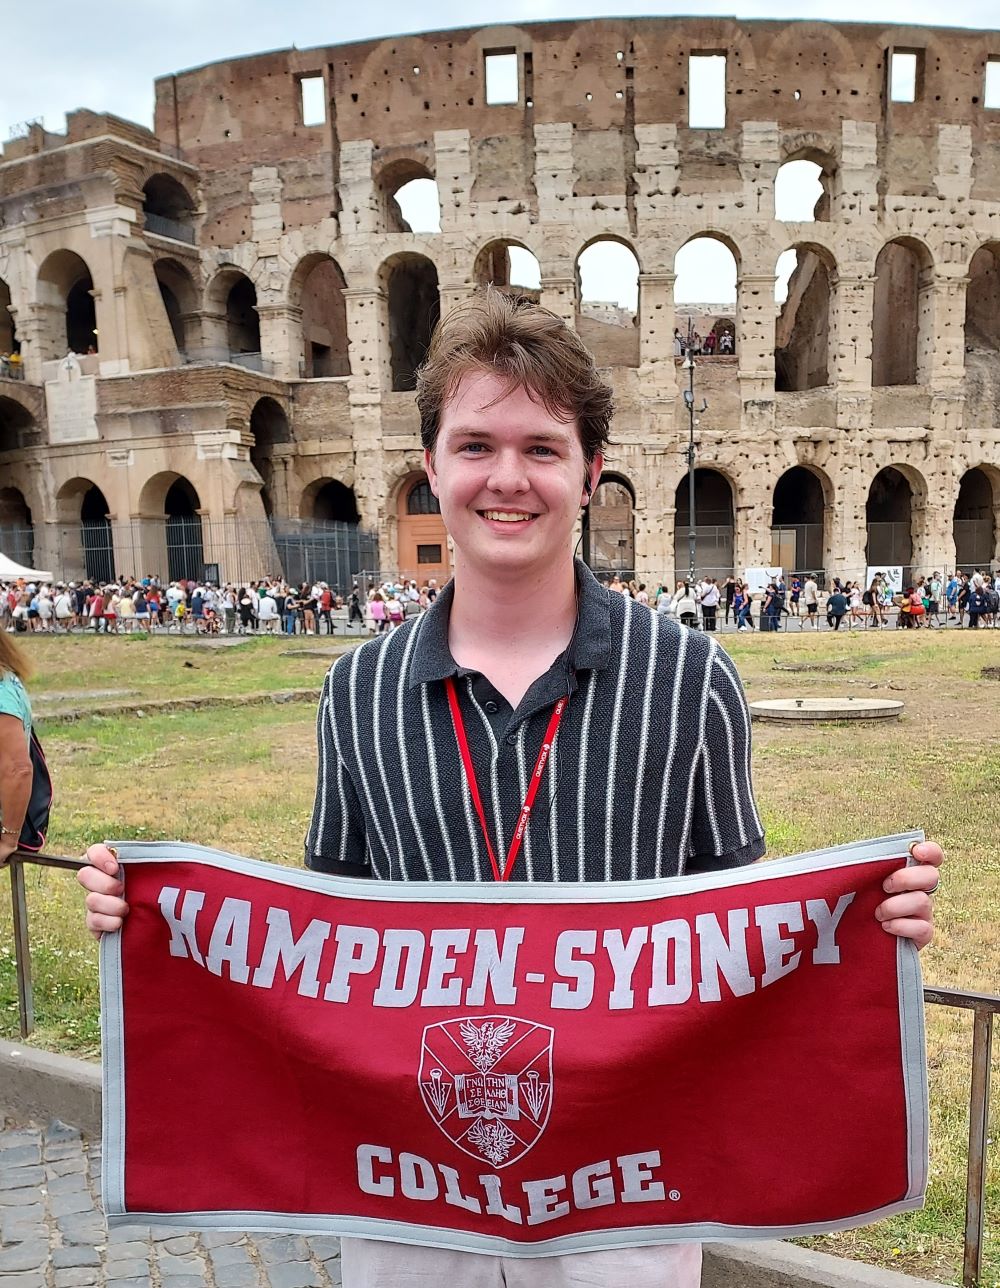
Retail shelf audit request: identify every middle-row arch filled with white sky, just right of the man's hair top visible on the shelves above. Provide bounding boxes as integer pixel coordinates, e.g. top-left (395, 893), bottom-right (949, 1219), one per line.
top-left (576, 237), bottom-right (639, 367)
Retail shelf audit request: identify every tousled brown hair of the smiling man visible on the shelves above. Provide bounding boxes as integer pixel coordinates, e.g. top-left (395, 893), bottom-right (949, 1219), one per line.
top-left (416, 286), bottom-right (615, 465)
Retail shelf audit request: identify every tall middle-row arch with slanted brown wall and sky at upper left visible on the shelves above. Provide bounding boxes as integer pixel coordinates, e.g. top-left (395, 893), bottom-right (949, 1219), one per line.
top-left (774, 246), bottom-right (830, 393)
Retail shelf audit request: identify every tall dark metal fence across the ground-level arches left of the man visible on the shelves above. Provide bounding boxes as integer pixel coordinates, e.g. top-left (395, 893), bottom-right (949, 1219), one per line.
top-left (0, 514), bottom-right (379, 594)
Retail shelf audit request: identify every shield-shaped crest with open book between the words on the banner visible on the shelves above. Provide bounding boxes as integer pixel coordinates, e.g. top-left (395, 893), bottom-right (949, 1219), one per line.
top-left (419, 1015), bottom-right (554, 1167)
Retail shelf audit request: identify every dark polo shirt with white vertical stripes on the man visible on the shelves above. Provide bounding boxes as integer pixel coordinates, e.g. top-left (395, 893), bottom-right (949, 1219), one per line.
top-left (305, 562), bottom-right (764, 881)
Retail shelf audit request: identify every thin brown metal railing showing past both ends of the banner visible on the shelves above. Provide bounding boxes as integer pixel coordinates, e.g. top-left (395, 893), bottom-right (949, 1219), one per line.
top-left (9, 850), bottom-right (1000, 1288)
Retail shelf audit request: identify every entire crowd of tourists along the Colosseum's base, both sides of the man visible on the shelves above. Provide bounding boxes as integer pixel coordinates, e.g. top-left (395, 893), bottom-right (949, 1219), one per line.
top-left (0, 569), bottom-right (1000, 635)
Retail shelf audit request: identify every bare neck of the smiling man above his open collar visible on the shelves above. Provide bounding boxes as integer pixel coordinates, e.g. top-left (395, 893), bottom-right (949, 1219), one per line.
top-left (448, 558), bottom-right (576, 706)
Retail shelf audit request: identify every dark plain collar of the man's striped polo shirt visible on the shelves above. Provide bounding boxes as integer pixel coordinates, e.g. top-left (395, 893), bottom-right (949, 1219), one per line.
top-left (409, 559), bottom-right (611, 689)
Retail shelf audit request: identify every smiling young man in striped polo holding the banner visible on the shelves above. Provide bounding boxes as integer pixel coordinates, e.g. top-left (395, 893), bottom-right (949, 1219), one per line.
top-left (74, 292), bottom-right (941, 1288)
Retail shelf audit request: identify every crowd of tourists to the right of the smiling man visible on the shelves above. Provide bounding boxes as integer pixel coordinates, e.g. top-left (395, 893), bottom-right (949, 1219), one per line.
top-left (608, 569), bottom-right (1000, 631)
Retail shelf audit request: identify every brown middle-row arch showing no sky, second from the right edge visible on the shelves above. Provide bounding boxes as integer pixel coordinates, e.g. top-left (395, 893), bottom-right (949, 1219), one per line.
top-left (871, 240), bottom-right (933, 386)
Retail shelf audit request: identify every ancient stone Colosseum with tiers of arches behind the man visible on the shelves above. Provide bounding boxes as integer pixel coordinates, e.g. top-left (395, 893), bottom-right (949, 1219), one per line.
top-left (0, 18), bottom-right (1000, 585)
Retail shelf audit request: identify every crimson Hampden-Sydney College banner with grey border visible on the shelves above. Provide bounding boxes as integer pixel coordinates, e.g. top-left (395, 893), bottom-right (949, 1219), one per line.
top-left (101, 836), bottom-right (927, 1256)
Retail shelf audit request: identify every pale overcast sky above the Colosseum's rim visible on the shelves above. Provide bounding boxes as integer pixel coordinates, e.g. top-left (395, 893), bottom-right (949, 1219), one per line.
top-left (0, 0), bottom-right (1000, 303)
